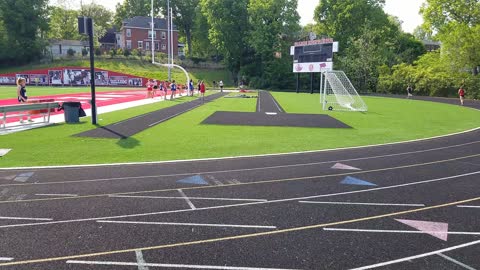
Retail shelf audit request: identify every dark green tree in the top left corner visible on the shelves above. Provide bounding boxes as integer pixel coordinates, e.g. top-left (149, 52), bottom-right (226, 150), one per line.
top-left (0, 0), bottom-right (48, 65)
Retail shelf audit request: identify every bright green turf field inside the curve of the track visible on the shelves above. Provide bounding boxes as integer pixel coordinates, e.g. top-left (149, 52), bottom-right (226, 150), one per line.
top-left (0, 93), bottom-right (480, 167)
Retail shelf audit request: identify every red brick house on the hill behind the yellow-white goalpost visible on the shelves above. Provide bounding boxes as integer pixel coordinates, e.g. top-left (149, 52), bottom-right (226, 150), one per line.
top-left (116, 17), bottom-right (180, 55)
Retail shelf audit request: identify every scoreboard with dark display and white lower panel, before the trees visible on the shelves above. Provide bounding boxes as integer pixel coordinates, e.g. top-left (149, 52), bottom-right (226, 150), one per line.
top-left (290, 38), bottom-right (338, 73)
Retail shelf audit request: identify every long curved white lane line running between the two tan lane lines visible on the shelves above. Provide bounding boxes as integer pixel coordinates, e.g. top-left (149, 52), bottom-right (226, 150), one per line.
top-left (0, 171), bottom-right (480, 229)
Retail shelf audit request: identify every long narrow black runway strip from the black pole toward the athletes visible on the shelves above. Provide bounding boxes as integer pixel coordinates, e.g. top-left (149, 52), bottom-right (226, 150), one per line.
top-left (75, 93), bottom-right (226, 139)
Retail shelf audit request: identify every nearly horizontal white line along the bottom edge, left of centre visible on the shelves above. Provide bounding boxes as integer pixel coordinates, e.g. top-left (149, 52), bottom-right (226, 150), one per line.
top-left (67, 260), bottom-right (299, 270)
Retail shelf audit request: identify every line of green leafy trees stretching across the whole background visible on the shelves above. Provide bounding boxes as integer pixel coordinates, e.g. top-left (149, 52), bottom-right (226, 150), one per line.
top-left (0, 0), bottom-right (480, 97)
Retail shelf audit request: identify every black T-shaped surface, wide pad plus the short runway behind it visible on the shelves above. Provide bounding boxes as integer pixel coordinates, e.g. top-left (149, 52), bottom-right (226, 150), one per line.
top-left (202, 91), bottom-right (351, 128)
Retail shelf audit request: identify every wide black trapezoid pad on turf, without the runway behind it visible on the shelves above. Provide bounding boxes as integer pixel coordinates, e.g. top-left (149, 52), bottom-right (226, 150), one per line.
top-left (202, 112), bottom-right (351, 128)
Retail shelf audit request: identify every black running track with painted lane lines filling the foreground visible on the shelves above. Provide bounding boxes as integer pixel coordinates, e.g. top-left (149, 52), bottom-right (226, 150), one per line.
top-left (0, 96), bottom-right (480, 270)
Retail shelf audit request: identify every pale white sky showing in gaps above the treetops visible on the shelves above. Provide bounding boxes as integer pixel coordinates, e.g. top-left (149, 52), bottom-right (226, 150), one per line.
top-left (55, 0), bottom-right (425, 33)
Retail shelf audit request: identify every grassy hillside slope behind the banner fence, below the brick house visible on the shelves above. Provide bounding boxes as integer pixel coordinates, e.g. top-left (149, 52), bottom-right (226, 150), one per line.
top-left (0, 58), bottom-right (233, 86)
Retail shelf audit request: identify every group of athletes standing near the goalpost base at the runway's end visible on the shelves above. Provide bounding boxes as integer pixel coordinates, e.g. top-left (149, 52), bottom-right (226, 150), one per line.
top-left (145, 79), bottom-right (206, 100)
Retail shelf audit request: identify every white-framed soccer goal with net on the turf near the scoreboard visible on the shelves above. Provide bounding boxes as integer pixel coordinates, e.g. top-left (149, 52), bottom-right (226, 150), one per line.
top-left (320, 70), bottom-right (368, 112)
